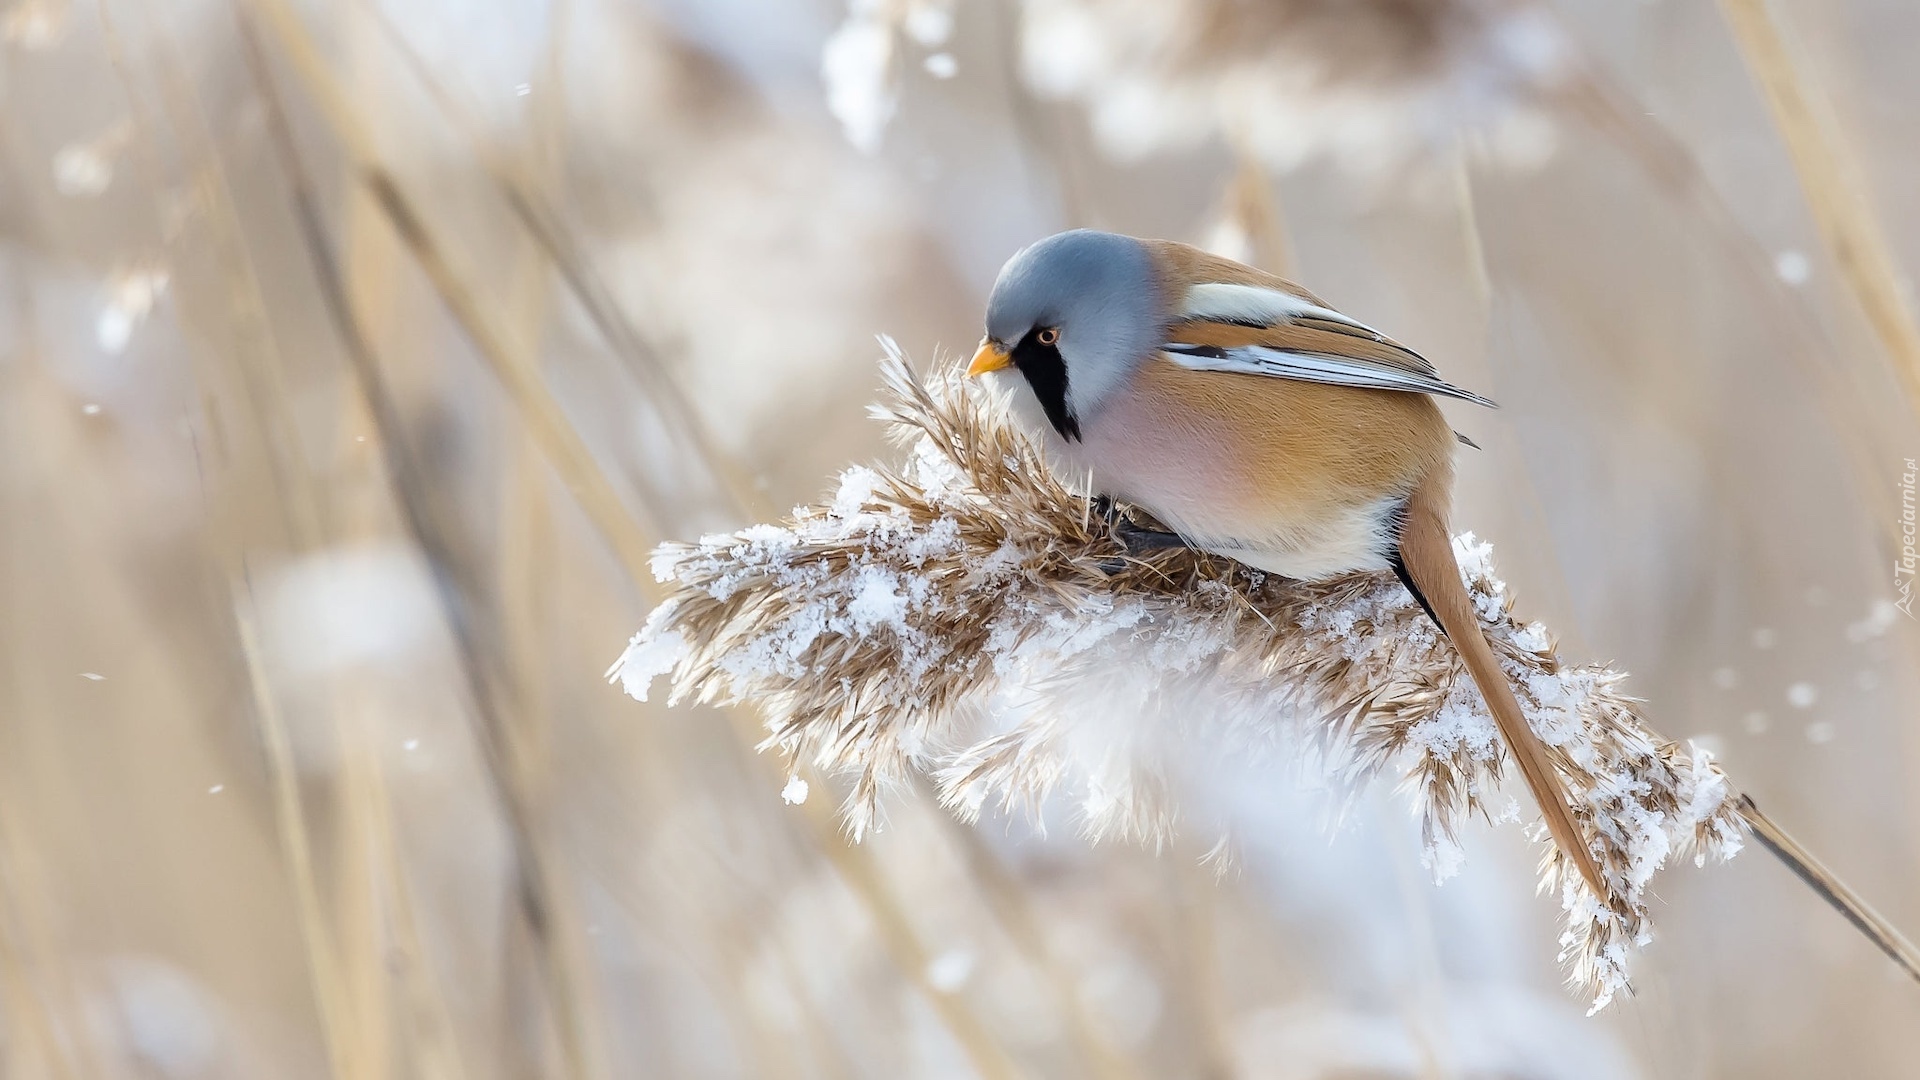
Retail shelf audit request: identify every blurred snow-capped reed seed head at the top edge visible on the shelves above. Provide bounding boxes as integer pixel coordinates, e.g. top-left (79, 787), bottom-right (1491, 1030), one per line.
top-left (1023, 0), bottom-right (1569, 173)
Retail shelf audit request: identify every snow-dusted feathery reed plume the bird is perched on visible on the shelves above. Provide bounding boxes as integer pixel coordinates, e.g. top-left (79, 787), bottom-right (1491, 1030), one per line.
top-left (609, 342), bottom-right (1743, 1009)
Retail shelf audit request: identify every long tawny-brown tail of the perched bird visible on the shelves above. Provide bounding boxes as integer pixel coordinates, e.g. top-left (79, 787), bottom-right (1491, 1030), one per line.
top-left (1396, 486), bottom-right (1613, 903)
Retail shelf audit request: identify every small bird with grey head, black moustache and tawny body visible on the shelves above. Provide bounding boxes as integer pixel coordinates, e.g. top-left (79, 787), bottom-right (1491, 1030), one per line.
top-left (968, 229), bottom-right (1611, 901)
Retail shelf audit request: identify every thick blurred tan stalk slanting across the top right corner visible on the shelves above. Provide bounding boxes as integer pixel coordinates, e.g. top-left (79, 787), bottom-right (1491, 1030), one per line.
top-left (1720, 0), bottom-right (1920, 415)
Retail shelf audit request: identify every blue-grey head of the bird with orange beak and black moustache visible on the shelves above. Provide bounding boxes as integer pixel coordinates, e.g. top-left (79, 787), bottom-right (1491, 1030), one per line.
top-left (968, 229), bottom-right (1165, 440)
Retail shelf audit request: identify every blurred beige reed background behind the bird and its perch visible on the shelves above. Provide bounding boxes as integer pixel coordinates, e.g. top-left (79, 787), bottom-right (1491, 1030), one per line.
top-left (0, 0), bottom-right (1920, 1080)
